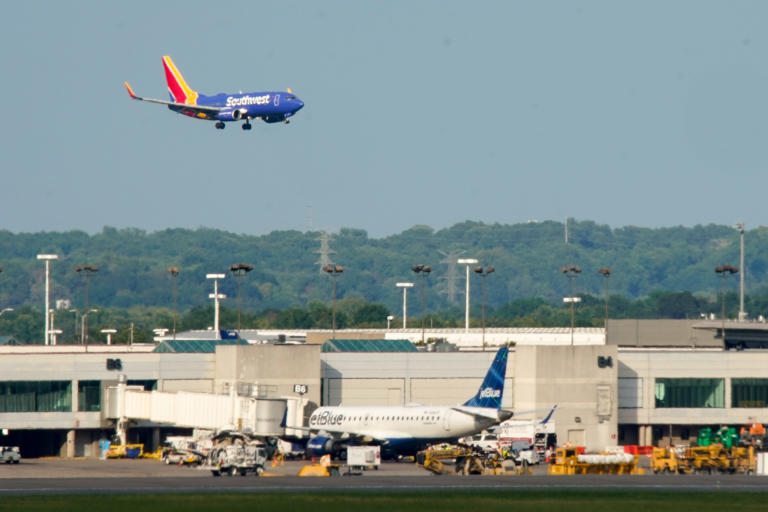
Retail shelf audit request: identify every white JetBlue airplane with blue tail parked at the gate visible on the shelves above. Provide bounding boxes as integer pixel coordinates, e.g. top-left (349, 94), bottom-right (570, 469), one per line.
top-left (296, 347), bottom-right (513, 457)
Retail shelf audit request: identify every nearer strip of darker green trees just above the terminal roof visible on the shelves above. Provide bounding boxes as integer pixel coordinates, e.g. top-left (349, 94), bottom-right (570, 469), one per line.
top-left (0, 291), bottom-right (752, 344)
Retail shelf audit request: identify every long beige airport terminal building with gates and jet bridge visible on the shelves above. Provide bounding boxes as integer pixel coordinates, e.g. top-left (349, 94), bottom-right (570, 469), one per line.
top-left (0, 320), bottom-right (768, 457)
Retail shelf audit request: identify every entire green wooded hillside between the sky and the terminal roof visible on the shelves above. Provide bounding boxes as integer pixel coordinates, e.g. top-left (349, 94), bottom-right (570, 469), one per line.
top-left (0, 219), bottom-right (768, 340)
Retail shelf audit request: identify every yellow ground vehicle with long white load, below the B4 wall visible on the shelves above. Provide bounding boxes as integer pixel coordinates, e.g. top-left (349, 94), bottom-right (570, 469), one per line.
top-left (548, 447), bottom-right (643, 475)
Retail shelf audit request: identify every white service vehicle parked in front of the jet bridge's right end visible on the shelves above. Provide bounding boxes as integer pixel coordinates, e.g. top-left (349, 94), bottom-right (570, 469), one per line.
top-left (203, 431), bottom-right (267, 476)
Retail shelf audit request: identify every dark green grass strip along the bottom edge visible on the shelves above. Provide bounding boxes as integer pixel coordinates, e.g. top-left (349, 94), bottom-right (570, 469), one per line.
top-left (0, 490), bottom-right (768, 512)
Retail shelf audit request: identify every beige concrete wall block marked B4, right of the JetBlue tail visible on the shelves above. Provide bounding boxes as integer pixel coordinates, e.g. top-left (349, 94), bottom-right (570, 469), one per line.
top-left (514, 346), bottom-right (619, 450)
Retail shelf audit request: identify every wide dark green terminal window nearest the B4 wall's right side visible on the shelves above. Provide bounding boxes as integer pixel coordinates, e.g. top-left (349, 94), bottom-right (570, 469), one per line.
top-left (654, 378), bottom-right (725, 408)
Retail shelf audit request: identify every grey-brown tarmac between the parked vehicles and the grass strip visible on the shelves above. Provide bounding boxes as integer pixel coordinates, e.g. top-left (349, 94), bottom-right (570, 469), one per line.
top-left (0, 459), bottom-right (768, 496)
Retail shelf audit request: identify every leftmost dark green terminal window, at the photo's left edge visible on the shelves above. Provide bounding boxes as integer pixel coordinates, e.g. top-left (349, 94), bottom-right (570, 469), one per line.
top-left (0, 381), bottom-right (72, 412)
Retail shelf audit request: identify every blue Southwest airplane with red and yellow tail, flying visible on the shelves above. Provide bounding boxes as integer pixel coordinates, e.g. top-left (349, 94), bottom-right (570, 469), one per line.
top-left (125, 55), bottom-right (304, 130)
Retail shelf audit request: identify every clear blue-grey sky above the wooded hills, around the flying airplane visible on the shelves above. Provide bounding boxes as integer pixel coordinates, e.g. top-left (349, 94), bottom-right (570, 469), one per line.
top-left (0, 0), bottom-right (768, 237)
